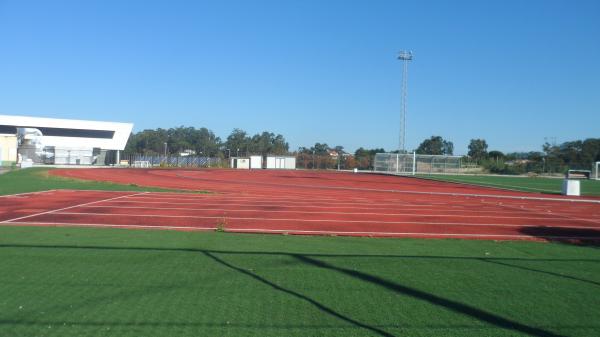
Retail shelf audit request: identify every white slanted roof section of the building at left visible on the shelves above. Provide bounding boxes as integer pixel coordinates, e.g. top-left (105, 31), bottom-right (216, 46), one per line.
top-left (0, 115), bottom-right (133, 150)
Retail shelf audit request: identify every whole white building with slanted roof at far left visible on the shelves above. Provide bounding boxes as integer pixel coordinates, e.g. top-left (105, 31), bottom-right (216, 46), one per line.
top-left (0, 115), bottom-right (133, 165)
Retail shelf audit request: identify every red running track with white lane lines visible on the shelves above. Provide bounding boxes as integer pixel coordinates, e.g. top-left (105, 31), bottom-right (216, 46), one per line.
top-left (0, 169), bottom-right (600, 240)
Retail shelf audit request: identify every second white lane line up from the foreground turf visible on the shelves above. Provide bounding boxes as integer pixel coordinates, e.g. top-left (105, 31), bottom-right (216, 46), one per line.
top-left (42, 211), bottom-right (599, 229)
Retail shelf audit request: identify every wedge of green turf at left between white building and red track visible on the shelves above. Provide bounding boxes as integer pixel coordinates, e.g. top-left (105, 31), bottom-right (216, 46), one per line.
top-left (0, 168), bottom-right (201, 195)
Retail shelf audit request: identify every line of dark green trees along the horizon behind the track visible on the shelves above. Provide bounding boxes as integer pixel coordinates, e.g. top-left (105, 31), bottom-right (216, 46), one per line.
top-left (124, 126), bottom-right (600, 174)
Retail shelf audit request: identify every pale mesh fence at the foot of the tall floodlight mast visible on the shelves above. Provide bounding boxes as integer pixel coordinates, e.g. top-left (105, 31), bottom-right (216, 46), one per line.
top-left (374, 153), bottom-right (461, 174)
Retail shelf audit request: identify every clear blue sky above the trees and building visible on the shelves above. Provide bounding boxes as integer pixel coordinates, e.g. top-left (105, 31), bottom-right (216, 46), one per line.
top-left (0, 0), bottom-right (600, 154)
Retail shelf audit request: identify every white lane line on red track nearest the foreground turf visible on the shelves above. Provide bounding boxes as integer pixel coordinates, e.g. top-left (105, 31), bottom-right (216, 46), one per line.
top-left (5, 221), bottom-right (600, 240)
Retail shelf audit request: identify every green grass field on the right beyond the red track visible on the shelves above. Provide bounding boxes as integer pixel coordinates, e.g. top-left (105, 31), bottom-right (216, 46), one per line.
top-left (420, 174), bottom-right (600, 196)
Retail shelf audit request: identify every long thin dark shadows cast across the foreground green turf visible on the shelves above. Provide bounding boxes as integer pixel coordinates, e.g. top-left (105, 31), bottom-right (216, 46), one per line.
top-left (0, 244), bottom-right (600, 337)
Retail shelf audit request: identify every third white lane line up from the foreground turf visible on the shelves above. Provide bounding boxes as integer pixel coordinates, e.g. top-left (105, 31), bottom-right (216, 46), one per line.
top-left (77, 205), bottom-right (600, 224)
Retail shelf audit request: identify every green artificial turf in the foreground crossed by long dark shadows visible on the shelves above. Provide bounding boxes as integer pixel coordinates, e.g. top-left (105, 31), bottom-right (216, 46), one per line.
top-left (0, 227), bottom-right (600, 337)
